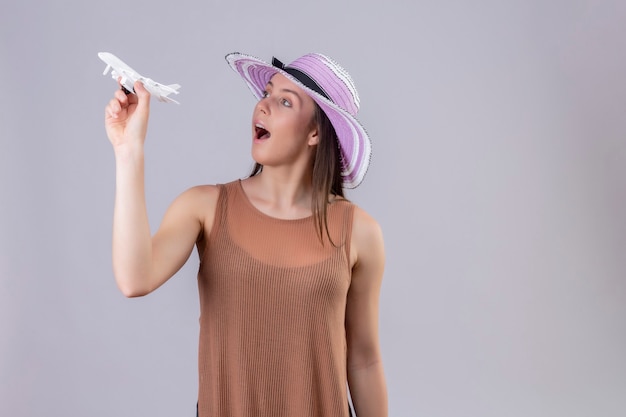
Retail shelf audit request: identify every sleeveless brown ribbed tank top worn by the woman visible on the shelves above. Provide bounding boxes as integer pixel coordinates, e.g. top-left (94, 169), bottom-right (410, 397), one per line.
top-left (198, 181), bottom-right (354, 417)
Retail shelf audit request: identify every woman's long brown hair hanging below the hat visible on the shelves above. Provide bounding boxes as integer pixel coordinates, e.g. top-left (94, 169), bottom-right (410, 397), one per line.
top-left (250, 103), bottom-right (345, 246)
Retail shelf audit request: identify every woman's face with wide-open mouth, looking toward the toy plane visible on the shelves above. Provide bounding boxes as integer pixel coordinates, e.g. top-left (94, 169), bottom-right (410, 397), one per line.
top-left (252, 74), bottom-right (318, 166)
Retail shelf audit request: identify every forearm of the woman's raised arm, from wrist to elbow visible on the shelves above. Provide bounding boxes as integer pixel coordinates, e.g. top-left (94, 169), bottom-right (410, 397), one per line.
top-left (112, 147), bottom-right (152, 297)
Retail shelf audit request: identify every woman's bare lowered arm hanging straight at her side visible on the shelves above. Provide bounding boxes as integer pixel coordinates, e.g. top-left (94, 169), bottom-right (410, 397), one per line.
top-left (346, 208), bottom-right (388, 417)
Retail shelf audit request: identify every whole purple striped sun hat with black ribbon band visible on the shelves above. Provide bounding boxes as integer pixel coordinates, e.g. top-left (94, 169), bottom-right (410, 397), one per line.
top-left (226, 52), bottom-right (372, 188)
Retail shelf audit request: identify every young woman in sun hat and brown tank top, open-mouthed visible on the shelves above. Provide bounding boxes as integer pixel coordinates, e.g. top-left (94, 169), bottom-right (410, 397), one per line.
top-left (105, 53), bottom-right (387, 417)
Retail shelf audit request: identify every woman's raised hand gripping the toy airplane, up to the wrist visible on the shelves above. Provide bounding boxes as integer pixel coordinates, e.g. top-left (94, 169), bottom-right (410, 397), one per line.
top-left (104, 81), bottom-right (150, 149)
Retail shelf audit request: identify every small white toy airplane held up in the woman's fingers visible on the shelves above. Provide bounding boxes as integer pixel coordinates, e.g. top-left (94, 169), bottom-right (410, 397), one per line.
top-left (98, 52), bottom-right (180, 104)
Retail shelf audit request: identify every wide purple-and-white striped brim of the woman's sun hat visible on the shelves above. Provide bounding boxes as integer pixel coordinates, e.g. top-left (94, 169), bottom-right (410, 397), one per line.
top-left (226, 52), bottom-right (372, 188)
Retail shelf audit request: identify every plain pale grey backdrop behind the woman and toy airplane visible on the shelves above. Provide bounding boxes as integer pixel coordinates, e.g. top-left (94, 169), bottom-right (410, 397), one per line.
top-left (0, 0), bottom-right (626, 417)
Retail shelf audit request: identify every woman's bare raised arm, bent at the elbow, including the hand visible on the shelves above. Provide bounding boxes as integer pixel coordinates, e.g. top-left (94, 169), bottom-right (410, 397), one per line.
top-left (105, 82), bottom-right (212, 297)
